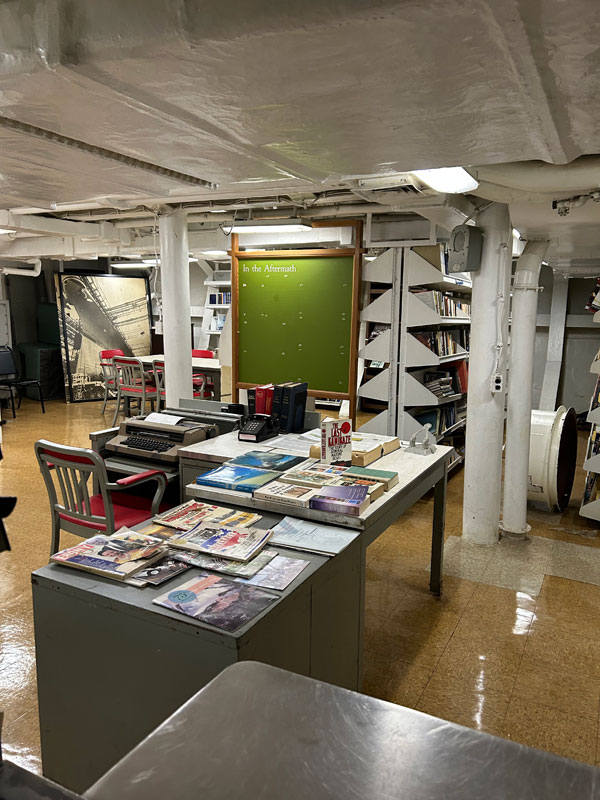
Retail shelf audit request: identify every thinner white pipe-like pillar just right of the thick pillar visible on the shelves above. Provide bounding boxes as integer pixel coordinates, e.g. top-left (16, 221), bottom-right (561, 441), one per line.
top-left (500, 241), bottom-right (548, 537)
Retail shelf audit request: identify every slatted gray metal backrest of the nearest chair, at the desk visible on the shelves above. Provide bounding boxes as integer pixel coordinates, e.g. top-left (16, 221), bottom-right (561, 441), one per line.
top-left (34, 439), bottom-right (115, 533)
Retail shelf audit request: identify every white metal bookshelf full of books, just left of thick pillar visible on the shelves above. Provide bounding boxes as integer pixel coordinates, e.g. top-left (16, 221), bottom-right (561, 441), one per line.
top-left (398, 245), bottom-right (471, 456)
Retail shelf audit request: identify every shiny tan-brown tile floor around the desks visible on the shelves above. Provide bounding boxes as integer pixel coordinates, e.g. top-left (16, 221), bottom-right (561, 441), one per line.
top-left (0, 401), bottom-right (600, 771)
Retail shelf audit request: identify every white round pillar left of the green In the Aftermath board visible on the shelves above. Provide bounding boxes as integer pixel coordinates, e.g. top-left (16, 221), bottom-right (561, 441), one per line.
top-left (158, 209), bottom-right (193, 408)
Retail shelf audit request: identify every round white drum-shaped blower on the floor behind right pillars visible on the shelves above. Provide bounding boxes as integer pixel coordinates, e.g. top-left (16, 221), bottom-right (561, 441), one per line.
top-left (527, 406), bottom-right (577, 511)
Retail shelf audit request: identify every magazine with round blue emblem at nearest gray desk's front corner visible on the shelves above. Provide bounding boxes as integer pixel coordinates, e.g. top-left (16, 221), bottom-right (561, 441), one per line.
top-left (152, 572), bottom-right (278, 632)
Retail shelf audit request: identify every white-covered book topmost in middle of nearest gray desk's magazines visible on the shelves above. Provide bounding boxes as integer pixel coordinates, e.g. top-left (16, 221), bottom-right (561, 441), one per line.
top-left (169, 525), bottom-right (272, 561)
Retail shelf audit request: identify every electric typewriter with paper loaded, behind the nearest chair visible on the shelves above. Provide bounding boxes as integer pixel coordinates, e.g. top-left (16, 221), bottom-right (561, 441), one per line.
top-left (106, 414), bottom-right (219, 464)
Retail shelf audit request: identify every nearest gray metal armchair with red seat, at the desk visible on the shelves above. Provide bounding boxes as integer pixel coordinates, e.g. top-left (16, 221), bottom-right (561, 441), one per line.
top-left (34, 439), bottom-right (167, 555)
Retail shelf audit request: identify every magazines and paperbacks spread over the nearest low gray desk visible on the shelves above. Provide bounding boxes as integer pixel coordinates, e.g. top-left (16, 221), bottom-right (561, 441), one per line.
top-left (51, 500), bottom-right (368, 631)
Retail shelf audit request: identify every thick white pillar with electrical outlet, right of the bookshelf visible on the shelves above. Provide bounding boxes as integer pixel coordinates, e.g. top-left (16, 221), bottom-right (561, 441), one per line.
top-left (463, 203), bottom-right (512, 545)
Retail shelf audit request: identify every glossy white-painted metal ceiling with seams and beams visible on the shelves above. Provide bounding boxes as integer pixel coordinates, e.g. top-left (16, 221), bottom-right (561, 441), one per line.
top-left (0, 0), bottom-right (600, 263)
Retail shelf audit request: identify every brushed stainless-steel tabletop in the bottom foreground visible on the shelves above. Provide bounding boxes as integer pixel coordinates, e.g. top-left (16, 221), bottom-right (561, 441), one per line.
top-left (84, 662), bottom-right (600, 800)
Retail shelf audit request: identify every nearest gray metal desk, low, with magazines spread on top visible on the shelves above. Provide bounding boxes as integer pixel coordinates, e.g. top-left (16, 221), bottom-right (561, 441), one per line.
top-left (32, 514), bottom-right (361, 792)
